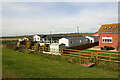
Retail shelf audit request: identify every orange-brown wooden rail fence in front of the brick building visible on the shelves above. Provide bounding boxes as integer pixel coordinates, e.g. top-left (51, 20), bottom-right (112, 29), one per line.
top-left (62, 48), bottom-right (120, 63)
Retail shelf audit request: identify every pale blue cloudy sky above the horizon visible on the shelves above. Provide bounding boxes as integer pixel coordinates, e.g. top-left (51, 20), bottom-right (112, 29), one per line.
top-left (2, 2), bottom-right (118, 36)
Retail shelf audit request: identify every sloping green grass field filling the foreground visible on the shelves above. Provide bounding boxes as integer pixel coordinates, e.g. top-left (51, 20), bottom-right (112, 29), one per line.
top-left (2, 48), bottom-right (118, 78)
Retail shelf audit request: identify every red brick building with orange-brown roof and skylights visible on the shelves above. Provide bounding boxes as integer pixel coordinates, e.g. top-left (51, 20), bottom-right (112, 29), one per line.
top-left (98, 23), bottom-right (120, 50)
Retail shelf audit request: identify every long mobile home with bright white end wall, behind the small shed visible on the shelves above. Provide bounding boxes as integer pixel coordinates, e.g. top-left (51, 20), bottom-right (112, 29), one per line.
top-left (59, 37), bottom-right (88, 47)
